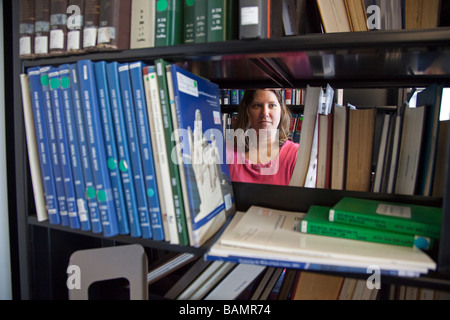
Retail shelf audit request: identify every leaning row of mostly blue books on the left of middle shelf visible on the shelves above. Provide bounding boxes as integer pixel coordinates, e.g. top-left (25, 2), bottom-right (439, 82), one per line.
top-left (23, 59), bottom-right (234, 246)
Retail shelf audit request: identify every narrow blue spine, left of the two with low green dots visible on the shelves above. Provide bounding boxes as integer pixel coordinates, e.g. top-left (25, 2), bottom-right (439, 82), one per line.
top-left (69, 63), bottom-right (102, 233)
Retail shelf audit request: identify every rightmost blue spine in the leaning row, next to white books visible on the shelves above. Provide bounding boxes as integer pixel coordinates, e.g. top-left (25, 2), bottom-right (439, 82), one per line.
top-left (130, 61), bottom-right (164, 241)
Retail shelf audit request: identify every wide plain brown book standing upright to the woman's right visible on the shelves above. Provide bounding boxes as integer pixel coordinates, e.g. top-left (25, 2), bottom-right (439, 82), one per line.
top-left (345, 109), bottom-right (376, 191)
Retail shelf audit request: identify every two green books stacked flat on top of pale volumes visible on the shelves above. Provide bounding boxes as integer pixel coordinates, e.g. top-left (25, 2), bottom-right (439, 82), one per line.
top-left (300, 197), bottom-right (442, 250)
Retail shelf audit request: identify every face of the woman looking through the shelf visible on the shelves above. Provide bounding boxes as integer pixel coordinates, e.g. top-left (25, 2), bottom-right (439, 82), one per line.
top-left (248, 90), bottom-right (281, 131)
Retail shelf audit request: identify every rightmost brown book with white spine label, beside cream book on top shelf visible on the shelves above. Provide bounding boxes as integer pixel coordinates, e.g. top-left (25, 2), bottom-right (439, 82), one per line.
top-left (97, 0), bottom-right (132, 50)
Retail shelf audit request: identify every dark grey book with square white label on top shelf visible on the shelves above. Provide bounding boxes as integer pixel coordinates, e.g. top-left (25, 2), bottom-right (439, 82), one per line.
top-left (239, 0), bottom-right (284, 39)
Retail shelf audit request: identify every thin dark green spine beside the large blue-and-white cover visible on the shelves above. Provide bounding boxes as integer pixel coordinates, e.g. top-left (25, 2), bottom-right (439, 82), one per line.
top-left (155, 59), bottom-right (189, 246)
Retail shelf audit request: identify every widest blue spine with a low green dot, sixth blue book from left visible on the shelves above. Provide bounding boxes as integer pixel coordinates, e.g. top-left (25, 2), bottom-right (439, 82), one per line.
top-left (77, 60), bottom-right (119, 237)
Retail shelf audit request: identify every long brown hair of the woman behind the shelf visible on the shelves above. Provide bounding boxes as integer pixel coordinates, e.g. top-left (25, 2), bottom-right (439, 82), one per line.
top-left (233, 89), bottom-right (291, 151)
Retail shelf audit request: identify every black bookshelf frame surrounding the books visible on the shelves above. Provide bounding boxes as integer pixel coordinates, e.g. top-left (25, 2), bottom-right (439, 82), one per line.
top-left (5, 1), bottom-right (450, 299)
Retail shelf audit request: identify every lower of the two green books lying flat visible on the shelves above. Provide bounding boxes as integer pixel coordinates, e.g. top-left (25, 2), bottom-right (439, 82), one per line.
top-left (300, 206), bottom-right (433, 250)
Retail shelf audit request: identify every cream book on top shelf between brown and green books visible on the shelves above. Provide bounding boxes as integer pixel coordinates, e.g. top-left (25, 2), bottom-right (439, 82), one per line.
top-left (130, 0), bottom-right (156, 49)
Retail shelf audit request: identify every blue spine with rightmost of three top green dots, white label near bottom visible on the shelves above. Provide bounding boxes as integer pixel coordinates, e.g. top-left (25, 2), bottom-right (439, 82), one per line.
top-left (58, 64), bottom-right (91, 230)
